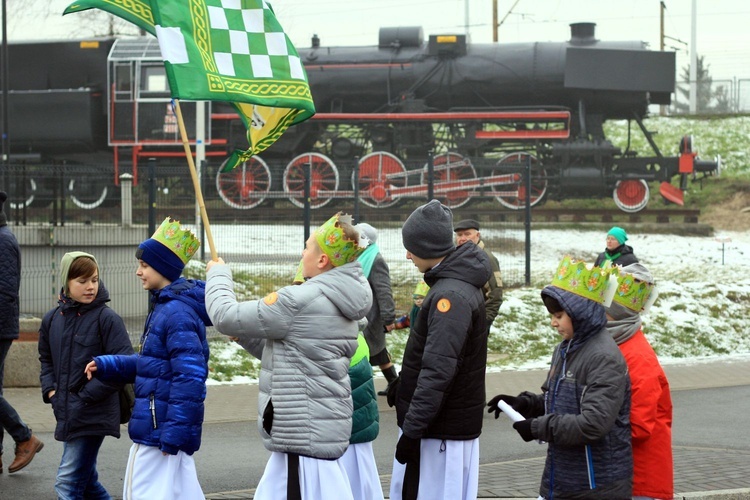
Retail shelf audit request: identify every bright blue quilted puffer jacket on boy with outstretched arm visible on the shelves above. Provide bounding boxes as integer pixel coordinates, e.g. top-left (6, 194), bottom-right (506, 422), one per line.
top-left (94, 278), bottom-right (211, 455)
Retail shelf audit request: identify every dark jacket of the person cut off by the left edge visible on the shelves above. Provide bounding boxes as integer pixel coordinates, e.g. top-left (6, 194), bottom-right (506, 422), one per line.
top-left (0, 222), bottom-right (21, 340)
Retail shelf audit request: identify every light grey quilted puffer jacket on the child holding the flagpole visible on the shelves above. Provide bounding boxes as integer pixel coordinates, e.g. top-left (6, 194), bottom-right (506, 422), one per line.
top-left (206, 262), bottom-right (372, 459)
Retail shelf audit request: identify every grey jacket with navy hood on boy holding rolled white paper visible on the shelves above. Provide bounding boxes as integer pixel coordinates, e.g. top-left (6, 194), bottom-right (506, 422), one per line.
top-left (531, 286), bottom-right (633, 500)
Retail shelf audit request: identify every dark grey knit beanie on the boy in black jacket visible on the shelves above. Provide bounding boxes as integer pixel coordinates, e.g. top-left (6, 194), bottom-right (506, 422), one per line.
top-left (401, 200), bottom-right (456, 259)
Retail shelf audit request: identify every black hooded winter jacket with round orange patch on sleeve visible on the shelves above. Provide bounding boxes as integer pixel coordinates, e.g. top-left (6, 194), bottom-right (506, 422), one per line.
top-left (396, 243), bottom-right (492, 440)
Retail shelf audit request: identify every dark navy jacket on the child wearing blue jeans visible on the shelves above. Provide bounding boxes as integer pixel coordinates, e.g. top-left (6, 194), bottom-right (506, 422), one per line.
top-left (39, 282), bottom-right (133, 441)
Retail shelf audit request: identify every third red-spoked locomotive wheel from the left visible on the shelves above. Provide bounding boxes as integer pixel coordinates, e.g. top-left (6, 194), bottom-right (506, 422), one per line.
top-left (352, 151), bottom-right (407, 208)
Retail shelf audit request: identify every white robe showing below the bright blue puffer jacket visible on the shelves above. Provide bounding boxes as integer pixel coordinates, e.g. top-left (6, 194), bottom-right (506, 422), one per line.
top-left (122, 443), bottom-right (206, 500)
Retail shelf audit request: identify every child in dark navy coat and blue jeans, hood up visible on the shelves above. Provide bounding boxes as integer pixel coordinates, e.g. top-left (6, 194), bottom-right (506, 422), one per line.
top-left (39, 252), bottom-right (133, 500)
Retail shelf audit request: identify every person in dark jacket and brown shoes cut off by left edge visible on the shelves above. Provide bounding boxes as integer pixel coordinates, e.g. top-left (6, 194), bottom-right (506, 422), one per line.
top-left (0, 191), bottom-right (44, 474)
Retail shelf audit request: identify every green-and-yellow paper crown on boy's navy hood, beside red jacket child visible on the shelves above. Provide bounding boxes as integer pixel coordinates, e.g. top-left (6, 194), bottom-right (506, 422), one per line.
top-left (551, 255), bottom-right (618, 307)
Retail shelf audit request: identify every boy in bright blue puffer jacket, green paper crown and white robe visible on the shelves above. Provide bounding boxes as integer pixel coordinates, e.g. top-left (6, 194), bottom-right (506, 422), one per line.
top-left (86, 217), bottom-right (211, 500)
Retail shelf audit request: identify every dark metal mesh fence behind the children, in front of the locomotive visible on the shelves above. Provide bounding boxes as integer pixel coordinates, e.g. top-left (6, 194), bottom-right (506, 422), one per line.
top-left (0, 162), bottom-right (528, 338)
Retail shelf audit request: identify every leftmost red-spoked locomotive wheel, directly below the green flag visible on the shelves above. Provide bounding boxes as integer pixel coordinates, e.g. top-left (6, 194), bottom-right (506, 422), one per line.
top-left (216, 156), bottom-right (271, 210)
